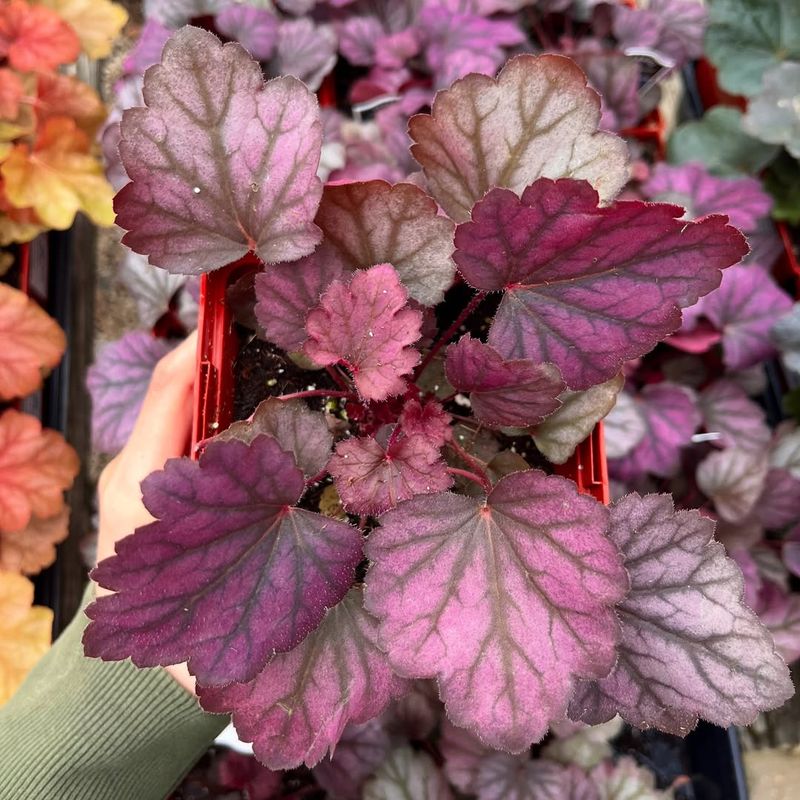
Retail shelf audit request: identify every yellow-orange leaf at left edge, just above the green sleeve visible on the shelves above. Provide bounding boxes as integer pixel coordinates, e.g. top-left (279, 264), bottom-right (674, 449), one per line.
top-left (0, 572), bottom-right (53, 705)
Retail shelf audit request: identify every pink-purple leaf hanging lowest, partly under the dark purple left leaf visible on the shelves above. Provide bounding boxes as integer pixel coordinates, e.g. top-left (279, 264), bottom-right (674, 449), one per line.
top-left (198, 589), bottom-right (408, 769)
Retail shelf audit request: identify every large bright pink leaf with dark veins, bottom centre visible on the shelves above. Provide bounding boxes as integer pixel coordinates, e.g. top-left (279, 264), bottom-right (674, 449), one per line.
top-left (366, 470), bottom-right (626, 752)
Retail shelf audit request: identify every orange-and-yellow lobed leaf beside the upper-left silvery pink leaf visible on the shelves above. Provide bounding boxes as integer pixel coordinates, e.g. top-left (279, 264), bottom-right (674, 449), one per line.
top-left (0, 117), bottom-right (114, 230)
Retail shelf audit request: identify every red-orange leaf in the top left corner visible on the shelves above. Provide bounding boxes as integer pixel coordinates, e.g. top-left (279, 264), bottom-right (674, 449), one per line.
top-left (0, 0), bottom-right (81, 72)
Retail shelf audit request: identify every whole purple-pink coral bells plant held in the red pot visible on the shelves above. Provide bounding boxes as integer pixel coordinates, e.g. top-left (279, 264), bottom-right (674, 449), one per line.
top-left (84, 27), bottom-right (793, 780)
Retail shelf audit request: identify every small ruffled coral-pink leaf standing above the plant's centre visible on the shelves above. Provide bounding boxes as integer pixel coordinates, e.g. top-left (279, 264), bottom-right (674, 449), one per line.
top-left (303, 264), bottom-right (422, 401)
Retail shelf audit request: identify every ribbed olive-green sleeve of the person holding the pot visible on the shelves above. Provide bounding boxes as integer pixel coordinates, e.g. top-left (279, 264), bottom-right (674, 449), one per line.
top-left (0, 588), bottom-right (228, 800)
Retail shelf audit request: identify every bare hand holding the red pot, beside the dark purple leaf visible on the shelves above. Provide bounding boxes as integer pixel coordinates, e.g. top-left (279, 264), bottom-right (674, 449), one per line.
top-left (96, 332), bottom-right (197, 692)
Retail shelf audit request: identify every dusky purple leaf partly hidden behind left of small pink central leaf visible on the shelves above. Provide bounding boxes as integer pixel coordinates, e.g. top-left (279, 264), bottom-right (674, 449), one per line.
top-left (255, 247), bottom-right (344, 353)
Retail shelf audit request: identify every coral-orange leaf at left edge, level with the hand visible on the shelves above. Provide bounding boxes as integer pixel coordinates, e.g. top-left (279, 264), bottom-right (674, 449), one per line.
top-left (0, 409), bottom-right (79, 531)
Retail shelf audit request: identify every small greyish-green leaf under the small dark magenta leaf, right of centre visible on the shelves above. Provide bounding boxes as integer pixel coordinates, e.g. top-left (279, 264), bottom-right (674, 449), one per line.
top-left (531, 373), bottom-right (625, 464)
